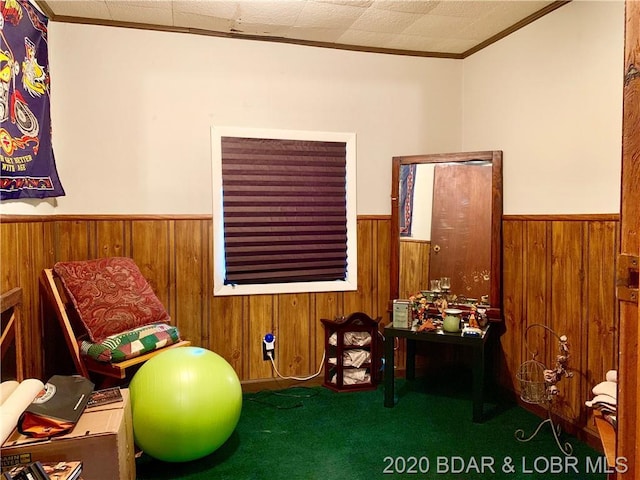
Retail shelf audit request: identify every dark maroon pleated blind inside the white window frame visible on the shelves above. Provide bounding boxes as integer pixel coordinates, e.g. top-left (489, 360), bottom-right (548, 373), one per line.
top-left (221, 137), bottom-right (347, 285)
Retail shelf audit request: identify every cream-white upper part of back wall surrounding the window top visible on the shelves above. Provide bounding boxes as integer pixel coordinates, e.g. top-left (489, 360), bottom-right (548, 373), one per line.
top-left (2, 22), bottom-right (462, 215)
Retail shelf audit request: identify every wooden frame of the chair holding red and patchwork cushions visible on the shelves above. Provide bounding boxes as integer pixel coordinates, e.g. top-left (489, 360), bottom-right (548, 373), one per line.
top-left (40, 269), bottom-right (191, 388)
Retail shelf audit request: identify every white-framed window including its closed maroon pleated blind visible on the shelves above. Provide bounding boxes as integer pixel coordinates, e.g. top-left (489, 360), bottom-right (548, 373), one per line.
top-left (212, 127), bottom-right (357, 295)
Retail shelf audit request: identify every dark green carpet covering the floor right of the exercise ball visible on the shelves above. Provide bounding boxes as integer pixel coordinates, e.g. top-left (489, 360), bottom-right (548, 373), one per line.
top-left (137, 379), bottom-right (606, 480)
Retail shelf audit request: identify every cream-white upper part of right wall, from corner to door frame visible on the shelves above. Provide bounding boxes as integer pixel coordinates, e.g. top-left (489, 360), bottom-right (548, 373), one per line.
top-left (463, 1), bottom-right (624, 214)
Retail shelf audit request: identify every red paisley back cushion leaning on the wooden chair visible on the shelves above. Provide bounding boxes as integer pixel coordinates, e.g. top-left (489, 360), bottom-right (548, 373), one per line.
top-left (53, 257), bottom-right (170, 343)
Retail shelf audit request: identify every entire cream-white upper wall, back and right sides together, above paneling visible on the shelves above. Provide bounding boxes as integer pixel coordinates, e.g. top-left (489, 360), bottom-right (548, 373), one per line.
top-left (0, 0), bottom-right (624, 215)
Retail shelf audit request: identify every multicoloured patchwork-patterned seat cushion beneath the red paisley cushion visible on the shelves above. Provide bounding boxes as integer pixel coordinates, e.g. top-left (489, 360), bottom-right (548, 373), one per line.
top-left (80, 323), bottom-right (180, 363)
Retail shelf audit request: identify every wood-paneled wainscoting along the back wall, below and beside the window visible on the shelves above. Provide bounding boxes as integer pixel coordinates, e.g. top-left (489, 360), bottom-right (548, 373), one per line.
top-left (0, 215), bottom-right (390, 384)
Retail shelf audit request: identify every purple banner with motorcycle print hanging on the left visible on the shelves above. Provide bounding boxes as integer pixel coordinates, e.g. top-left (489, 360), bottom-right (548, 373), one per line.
top-left (0, 0), bottom-right (64, 200)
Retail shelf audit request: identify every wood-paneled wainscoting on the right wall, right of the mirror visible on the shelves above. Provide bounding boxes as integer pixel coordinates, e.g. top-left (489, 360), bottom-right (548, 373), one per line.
top-left (497, 215), bottom-right (620, 446)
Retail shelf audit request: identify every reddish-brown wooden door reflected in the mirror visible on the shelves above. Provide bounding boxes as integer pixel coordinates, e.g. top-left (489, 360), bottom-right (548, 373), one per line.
top-left (429, 162), bottom-right (492, 300)
